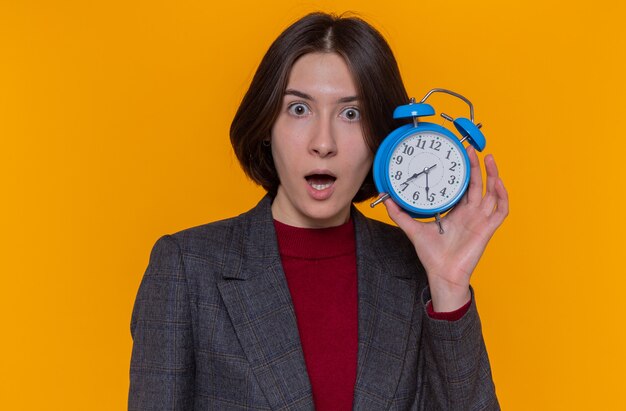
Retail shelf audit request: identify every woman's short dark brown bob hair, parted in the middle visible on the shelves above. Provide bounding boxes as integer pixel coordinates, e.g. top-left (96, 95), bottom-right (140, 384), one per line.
top-left (230, 13), bottom-right (408, 202)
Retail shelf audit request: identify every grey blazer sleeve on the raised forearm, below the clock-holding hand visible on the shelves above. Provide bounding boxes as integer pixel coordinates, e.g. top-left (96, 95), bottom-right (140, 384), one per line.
top-left (417, 288), bottom-right (500, 411)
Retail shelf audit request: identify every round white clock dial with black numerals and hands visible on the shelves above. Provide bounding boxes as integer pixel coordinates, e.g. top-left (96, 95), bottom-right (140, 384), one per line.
top-left (388, 131), bottom-right (468, 210)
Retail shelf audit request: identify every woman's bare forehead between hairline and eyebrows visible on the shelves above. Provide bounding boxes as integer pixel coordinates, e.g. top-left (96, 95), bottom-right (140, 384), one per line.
top-left (287, 53), bottom-right (356, 96)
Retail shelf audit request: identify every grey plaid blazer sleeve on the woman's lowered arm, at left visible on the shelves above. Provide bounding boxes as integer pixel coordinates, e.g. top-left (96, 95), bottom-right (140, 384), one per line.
top-left (128, 236), bottom-right (195, 410)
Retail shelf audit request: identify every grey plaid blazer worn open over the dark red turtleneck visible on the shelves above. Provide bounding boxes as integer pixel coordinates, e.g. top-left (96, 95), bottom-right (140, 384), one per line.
top-left (128, 196), bottom-right (499, 410)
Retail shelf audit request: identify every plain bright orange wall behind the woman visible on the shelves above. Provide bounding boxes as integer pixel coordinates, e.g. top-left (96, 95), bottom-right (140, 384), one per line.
top-left (0, 0), bottom-right (626, 410)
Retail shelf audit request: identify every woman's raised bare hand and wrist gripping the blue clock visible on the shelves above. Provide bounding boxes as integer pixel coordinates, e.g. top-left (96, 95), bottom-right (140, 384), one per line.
top-left (384, 147), bottom-right (509, 312)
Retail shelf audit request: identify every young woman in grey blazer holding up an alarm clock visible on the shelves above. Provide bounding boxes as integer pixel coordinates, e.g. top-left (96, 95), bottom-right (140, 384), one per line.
top-left (129, 13), bottom-right (508, 410)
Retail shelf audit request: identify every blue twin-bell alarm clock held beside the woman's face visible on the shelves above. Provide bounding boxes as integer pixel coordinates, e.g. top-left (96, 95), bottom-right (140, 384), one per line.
top-left (371, 88), bottom-right (486, 233)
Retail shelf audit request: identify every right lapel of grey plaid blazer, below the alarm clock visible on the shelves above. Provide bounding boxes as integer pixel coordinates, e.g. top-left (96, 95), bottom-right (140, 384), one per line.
top-left (353, 210), bottom-right (417, 409)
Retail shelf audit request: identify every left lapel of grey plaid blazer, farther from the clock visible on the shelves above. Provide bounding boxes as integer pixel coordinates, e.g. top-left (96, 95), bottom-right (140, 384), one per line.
top-left (218, 196), bottom-right (313, 409)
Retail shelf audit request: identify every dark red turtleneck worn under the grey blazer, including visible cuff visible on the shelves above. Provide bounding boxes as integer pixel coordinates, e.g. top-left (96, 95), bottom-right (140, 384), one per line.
top-left (274, 220), bottom-right (470, 411)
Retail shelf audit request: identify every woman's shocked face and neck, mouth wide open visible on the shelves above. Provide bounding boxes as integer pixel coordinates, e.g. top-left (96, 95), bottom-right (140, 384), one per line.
top-left (271, 53), bottom-right (372, 228)
